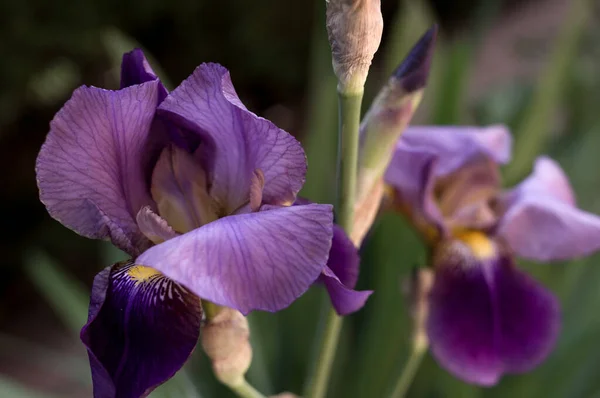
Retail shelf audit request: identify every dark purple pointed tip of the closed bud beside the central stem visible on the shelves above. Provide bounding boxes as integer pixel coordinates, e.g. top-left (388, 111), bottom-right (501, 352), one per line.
top-left (394, 24), bottom-right (438, 92)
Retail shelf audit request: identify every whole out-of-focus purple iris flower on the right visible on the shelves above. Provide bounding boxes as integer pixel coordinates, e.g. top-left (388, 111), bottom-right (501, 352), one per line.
top-left (385, 126), bottom-right (600, 385)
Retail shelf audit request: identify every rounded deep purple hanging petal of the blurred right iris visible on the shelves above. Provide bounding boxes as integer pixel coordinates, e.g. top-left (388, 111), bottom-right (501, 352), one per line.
top-left (428, 239), bottom-right (560, 385)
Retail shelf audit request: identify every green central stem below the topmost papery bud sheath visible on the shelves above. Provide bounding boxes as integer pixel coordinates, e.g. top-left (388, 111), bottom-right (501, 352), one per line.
top-left (304, 89), bottom-right (363, 398)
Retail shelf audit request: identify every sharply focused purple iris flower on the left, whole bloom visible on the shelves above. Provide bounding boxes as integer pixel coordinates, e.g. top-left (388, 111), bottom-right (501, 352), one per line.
top-left (36, 50), bottom-right (369, 398)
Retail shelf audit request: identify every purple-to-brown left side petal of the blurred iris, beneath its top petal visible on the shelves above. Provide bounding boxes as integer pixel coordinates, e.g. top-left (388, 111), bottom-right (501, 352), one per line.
top-left (385, 145), bottom-right (446, 236)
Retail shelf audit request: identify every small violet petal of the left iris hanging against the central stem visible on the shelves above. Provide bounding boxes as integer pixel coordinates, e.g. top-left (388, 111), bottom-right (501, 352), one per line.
top-left (319, 225), bottom-right (373, 315)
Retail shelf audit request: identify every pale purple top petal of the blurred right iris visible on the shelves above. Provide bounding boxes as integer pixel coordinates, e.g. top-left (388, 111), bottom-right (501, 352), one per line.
top-left (400, 125), bottom-right (512, 176)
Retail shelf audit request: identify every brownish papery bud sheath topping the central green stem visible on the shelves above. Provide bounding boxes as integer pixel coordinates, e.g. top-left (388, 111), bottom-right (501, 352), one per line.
top-left (326, 0), bottom-right (383, 93)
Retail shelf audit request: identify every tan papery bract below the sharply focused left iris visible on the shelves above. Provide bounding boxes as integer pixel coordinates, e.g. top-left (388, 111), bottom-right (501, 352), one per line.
top-left (201, 308), bottom-right (252, 386)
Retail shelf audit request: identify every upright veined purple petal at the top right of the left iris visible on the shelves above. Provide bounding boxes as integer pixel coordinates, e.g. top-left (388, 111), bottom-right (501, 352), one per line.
top-left (160, 64), bottom-right (306, 214)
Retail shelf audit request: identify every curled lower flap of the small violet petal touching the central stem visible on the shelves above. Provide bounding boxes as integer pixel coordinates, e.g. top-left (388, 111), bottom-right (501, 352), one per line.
top-left (319, 267), bottom-right (373, 315)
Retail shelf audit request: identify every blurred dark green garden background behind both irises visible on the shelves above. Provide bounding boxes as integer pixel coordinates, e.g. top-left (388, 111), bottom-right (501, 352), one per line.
top-left (0, 0), bottom-right (600, 398)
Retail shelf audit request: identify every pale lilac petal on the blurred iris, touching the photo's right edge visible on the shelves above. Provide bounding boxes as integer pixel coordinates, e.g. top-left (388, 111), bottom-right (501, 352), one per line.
top-left (497, 158), bottom-right (600, 261)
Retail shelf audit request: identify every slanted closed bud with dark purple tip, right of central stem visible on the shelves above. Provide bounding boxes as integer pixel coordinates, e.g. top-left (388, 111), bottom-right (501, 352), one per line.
top-left (351, 26), bottom-right (437, 246)
